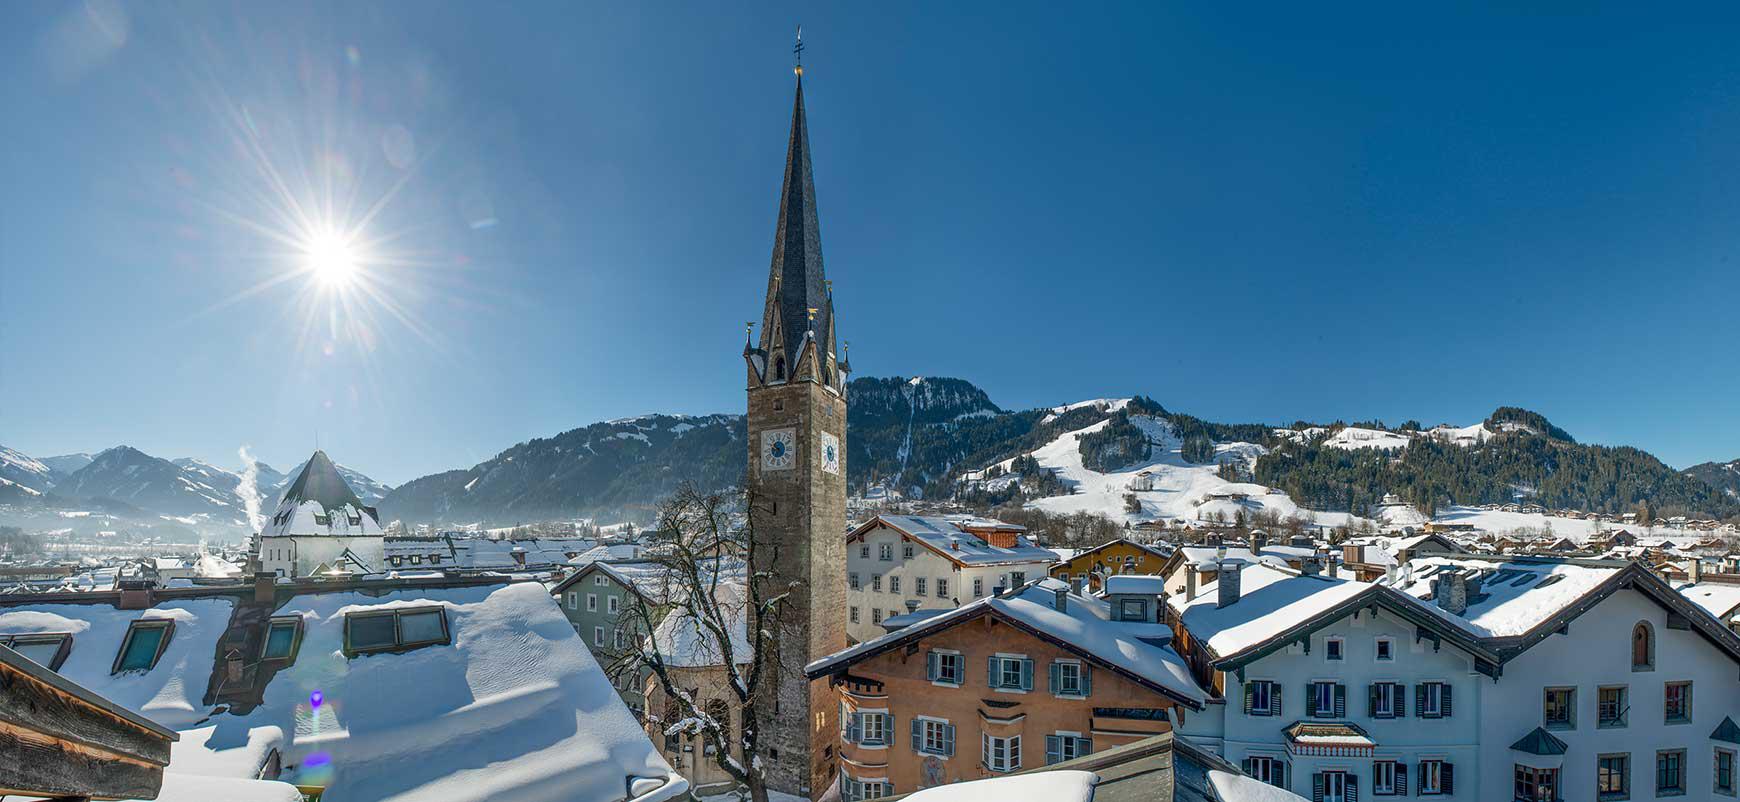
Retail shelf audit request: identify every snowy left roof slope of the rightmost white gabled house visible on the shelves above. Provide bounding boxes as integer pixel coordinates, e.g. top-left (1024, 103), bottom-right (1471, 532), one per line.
top-left (1385, 555), bottom-right (1623, 638)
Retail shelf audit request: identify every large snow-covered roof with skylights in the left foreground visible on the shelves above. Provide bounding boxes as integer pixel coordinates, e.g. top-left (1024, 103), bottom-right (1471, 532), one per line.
top-left (0, 581), bottom-right (687, 802)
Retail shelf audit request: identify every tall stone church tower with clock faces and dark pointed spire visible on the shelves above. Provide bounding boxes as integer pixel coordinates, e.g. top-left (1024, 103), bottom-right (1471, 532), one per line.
top-left (743, 56), bottom-right (849, 797)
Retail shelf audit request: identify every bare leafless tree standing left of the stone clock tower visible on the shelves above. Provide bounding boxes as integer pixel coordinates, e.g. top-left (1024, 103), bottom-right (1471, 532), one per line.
top-left (612, 484), bottom-right (802, 802)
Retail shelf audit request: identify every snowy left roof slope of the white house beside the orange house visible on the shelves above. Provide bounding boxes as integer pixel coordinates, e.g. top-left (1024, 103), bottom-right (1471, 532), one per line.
top-left (1168, 564), bottom-right (1373, 658)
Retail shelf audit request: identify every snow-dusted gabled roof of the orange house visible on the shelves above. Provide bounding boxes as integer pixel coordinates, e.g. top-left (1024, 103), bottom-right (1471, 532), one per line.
top-left (804, 578), bottom-right (1206, 705)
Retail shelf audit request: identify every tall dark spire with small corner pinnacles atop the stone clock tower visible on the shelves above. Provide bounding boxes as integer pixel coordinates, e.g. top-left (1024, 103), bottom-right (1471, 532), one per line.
top-left (757, 56), bottom-right (839, 386)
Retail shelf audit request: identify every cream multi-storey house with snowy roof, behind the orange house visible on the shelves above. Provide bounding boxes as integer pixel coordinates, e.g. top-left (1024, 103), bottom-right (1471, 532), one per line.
top-left (846, 515), bottom-right (1058, 642)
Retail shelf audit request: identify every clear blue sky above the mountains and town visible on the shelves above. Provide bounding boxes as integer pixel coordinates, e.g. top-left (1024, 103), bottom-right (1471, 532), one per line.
top-left (0, 2), bottom-right (1740, 482)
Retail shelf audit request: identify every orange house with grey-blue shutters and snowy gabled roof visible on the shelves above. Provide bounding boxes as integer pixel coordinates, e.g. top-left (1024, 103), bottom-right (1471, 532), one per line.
top-left (806, 578), bottom-right (1206, 800)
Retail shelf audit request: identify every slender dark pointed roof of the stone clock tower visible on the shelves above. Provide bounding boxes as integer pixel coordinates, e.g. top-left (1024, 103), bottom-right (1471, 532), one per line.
top-left (760, 75), bottom-right (833, 372)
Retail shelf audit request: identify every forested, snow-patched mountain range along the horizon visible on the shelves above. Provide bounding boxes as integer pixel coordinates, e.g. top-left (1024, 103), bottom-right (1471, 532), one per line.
top-left (10, 378), bottom-right (1740, 525)
